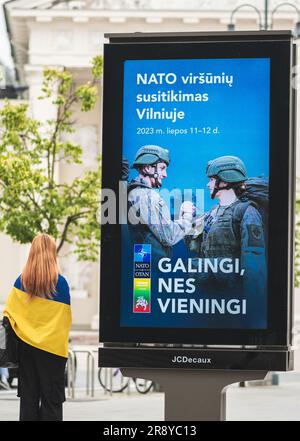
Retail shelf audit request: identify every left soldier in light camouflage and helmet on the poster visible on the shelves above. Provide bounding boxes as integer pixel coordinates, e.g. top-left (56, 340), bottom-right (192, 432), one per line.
top-left (128, 145), bottom-right (193, 260)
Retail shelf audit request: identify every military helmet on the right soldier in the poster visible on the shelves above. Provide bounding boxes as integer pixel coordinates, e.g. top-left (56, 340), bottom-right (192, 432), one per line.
top-left (206, 156), bottom-right (247, 183)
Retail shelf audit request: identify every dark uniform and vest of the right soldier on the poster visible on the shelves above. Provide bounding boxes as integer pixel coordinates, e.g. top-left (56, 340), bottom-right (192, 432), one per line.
top-left (186, 200), bottom-right (266, 294)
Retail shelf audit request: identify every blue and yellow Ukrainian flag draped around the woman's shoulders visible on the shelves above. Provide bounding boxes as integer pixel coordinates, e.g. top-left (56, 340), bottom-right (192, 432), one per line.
top-left (3, 275), bottom-right (72, 358)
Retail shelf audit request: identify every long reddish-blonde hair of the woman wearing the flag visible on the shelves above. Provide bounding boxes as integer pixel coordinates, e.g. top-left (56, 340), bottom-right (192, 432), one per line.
top-left (21, 233), bottom-right (58, 299)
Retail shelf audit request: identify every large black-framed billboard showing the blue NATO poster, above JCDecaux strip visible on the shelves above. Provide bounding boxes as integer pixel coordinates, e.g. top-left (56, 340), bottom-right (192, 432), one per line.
top-left (100, 33), bottom-right (295, 345)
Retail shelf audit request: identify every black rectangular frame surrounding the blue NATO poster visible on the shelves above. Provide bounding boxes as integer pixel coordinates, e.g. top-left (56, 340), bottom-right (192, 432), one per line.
top-left (100, 31), bottom-right (296, 350)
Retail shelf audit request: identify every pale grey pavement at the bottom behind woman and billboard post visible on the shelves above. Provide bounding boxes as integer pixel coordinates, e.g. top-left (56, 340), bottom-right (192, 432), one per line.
top-left (0, 381), bottom-right (300, 421)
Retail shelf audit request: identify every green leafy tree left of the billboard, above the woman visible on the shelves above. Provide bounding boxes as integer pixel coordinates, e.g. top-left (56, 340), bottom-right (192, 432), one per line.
top-left (0, 56), bottom-right (102, 260)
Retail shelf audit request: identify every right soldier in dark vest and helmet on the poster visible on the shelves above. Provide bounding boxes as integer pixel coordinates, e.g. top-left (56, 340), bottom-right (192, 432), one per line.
top-left (186, 156), bottom-right (266, 324)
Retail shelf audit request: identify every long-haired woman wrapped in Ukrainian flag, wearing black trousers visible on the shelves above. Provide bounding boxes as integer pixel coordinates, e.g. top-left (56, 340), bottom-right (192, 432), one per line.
top-left (4, 234), bottom-right (72, 421)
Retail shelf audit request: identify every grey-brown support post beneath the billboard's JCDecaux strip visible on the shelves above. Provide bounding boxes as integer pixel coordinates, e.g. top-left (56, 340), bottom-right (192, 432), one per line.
top-left (121, 369), bottom-right (267, 421)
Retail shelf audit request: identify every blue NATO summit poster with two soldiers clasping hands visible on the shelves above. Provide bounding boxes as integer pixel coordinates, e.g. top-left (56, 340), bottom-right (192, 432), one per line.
top-left (120, 58), bottom-right (270, 329)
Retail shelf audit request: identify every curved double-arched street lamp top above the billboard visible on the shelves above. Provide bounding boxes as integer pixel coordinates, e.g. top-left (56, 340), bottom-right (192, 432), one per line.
top-left (227, 0), bottom-right (300, 38)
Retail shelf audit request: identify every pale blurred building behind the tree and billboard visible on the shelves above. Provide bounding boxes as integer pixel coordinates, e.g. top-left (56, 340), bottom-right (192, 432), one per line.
top-left (0, 0), bottom-right (300, 328)
